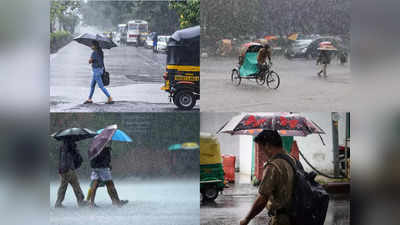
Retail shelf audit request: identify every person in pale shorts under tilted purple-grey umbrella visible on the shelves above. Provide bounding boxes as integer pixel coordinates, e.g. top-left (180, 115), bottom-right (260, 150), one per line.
top-left (88, 125), bottom-right (128, 207)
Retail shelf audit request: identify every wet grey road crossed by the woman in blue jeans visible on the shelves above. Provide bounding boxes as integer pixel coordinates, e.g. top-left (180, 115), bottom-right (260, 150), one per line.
top-left (50, 42), bottom-right (199, 112)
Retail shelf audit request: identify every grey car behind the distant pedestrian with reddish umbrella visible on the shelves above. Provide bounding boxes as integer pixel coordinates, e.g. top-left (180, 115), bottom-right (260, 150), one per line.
top-left (285, 36), bottom-right (344, 59)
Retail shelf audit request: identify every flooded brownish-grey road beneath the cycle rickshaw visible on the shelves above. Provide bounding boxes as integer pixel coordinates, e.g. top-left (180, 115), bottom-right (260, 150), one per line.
top-left (201, 57), bottom-right (352, 112)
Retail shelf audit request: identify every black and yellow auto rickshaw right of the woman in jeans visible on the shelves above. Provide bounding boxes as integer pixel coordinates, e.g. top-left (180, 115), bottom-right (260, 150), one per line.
top-left (161, 26), bottom-right (200, 110)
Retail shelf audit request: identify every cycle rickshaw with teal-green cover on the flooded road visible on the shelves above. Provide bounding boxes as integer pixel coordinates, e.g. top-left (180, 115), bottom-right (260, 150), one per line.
top-left (231, 42), bottom-right (280, 89)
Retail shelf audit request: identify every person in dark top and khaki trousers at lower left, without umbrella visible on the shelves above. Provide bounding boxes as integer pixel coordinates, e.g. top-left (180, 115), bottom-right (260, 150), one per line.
top-left (55, 140), bottom-right (86, 208)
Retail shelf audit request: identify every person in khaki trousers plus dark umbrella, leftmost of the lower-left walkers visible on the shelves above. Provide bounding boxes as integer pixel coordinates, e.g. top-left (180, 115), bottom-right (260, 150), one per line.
top-left (51, 128), bottom-right (96, 208)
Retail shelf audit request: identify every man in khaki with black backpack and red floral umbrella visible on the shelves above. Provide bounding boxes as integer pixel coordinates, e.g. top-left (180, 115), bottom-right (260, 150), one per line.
top-left (219, 113), bottom-right (329, 225)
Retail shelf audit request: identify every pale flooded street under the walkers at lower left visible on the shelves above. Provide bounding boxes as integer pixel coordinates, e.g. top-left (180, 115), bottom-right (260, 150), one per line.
top-left (50, 179), bottom-right (200, 225)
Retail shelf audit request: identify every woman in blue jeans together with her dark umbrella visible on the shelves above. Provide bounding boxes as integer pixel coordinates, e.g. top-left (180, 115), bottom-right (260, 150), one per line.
top-left (74, 34), bottom-right (117, 104)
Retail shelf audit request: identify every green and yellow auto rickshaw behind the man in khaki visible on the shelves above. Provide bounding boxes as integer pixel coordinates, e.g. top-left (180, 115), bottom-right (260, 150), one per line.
top-left (200, 133), bottom-right (224, 201)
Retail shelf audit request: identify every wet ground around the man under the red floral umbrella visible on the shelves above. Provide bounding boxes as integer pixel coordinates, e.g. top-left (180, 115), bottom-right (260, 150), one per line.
top-left (200, 184), bottom-right (350, 225)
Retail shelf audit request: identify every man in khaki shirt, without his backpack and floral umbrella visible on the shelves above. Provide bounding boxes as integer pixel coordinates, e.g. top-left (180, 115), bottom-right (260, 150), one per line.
top-left (240, 130), bottom-right (295, 225)
